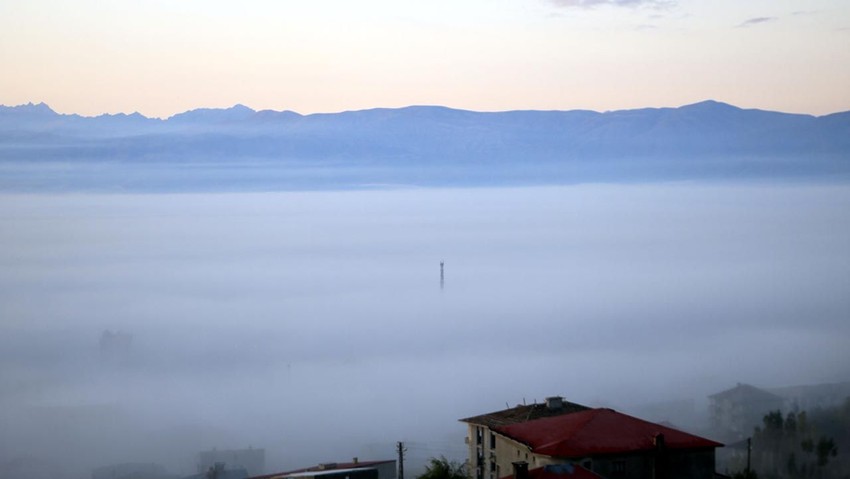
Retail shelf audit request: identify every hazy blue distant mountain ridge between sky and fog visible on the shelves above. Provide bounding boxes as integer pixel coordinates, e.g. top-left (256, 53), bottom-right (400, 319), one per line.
top-left (0, 100), bottom-right (850, 190)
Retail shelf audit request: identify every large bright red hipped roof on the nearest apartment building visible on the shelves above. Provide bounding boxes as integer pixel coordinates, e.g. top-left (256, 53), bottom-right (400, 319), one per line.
top-left (495, 409), bottom-right (723, 457)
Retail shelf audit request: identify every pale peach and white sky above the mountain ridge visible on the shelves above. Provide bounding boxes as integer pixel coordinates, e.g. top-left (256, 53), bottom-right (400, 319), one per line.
top-left (0, 0), bottom-right (850, 117)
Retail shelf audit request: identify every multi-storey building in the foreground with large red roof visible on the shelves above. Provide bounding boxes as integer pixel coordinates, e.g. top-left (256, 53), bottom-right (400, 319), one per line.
top-left (461, 397), bottom-right (722, 479)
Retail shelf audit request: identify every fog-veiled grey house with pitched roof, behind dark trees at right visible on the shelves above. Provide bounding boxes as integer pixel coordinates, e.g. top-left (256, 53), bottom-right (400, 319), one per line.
top-left (708, 383), bottom-right (785, 441)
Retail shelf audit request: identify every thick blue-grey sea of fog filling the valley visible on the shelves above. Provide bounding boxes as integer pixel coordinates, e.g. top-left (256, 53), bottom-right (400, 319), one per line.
top-left (0, 184), bottom-right (850, 478)
